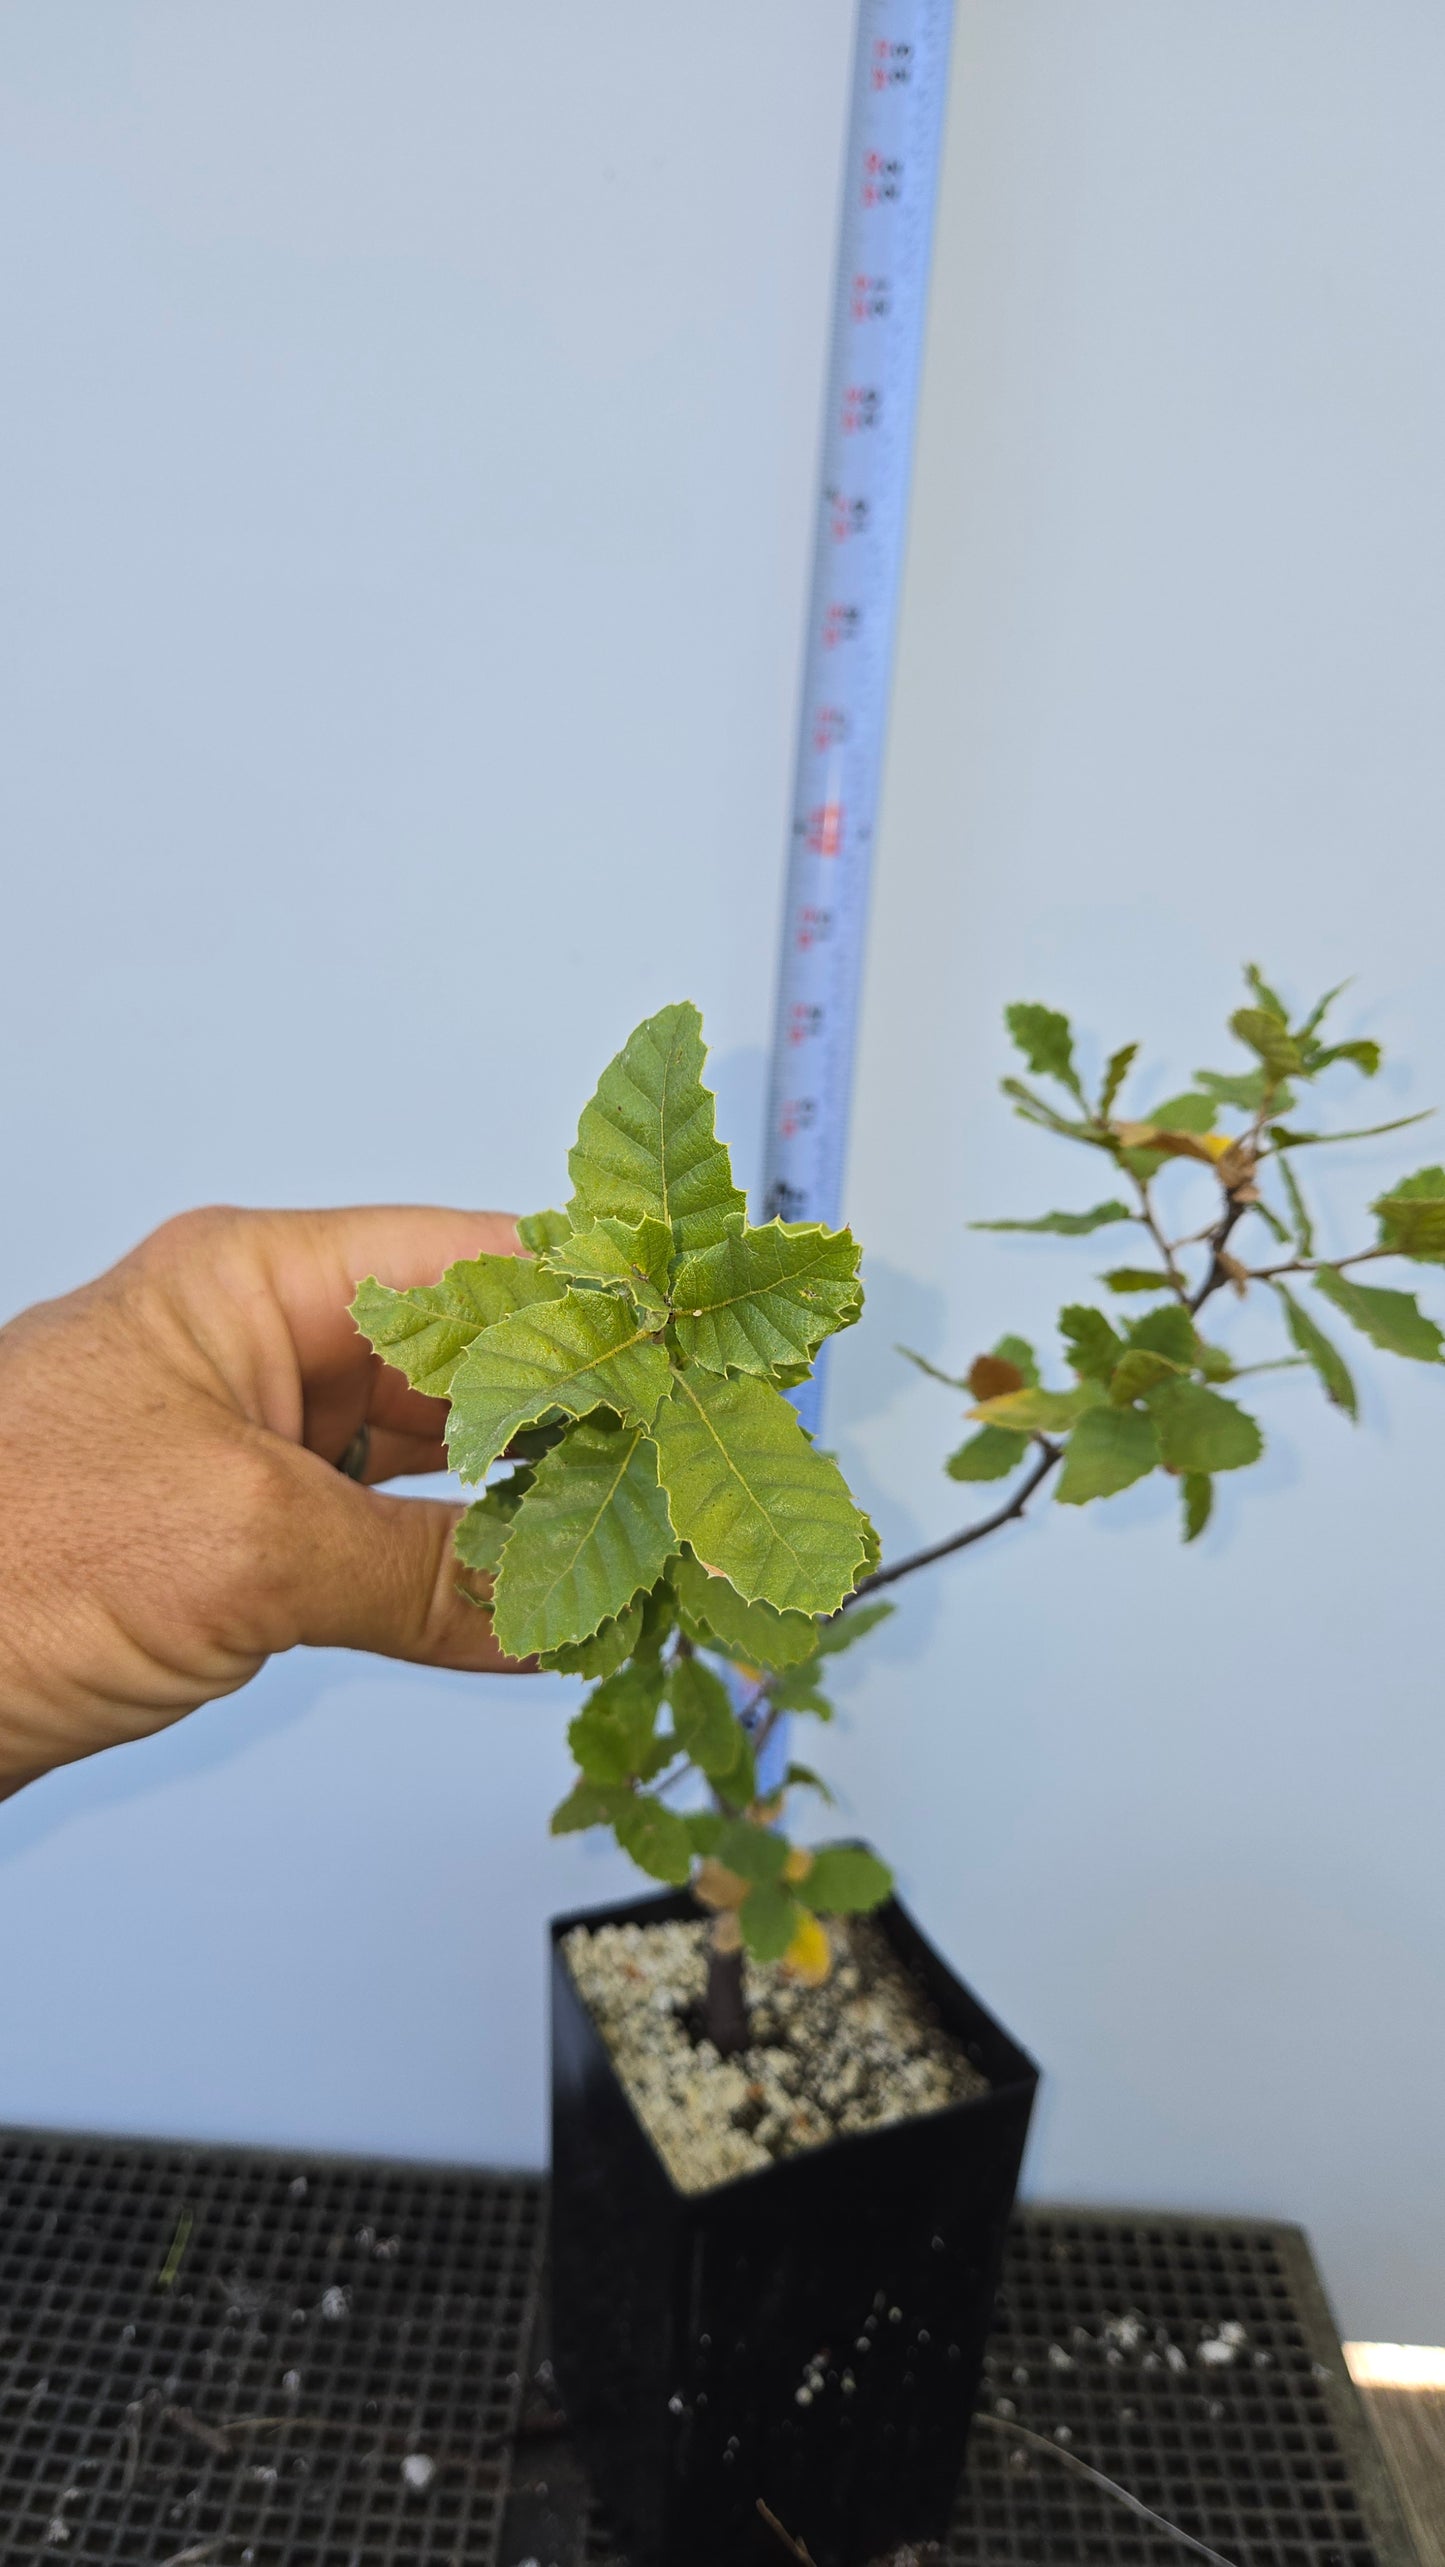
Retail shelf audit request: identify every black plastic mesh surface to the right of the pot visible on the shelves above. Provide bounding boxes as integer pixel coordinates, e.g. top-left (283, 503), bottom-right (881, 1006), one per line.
top-left (557, 2210), bottom-right (1414, 2567)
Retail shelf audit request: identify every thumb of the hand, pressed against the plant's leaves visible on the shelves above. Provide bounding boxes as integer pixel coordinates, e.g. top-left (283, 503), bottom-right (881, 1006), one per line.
top-left (267, 1450), bottom-right (526, 1674)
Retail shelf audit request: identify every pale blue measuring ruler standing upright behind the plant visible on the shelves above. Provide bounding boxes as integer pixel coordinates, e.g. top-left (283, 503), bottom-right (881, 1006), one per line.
top-left (762, 0), bottom-right (952, 1427)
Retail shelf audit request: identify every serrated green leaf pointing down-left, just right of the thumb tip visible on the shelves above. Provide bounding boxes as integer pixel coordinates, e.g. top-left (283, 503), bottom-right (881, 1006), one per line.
top-left (493, 1420), bottom-right (678, 1658)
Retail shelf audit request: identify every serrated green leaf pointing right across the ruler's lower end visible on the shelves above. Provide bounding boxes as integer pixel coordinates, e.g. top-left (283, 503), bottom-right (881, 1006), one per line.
top-left (672, 1222), bottom-right (862, 1373)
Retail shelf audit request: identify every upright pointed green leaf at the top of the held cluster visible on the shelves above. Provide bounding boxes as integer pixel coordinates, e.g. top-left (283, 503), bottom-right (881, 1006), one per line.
top-left (567, 1001), bottom-right (747, 1255)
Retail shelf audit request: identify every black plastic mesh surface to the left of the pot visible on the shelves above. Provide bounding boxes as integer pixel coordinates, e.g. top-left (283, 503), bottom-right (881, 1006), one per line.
top-left (0, 2133), bottom-right (542, 2567)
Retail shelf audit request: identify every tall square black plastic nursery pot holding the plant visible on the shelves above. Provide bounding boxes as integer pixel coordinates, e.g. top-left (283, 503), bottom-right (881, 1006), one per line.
top-left (552, 1892), bottom-right (1039, 2567)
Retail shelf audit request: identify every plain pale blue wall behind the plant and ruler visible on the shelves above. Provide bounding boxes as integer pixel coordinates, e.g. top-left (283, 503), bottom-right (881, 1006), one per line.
top-left (0, 0), bottom-right (1445, 2336)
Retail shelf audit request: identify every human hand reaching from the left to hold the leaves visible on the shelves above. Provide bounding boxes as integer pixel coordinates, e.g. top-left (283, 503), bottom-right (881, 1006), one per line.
top-left (0, 1204), bottom-right (531, 1797)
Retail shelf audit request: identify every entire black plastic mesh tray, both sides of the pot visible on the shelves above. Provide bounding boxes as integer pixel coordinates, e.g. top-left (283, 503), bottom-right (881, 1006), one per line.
top-left (0, 2131), bottom-right (1414, 2567)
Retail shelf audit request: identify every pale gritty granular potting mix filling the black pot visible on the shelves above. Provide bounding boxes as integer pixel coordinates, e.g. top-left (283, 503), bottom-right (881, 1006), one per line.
top-left (565, 1918), bottom-right (988, 2192)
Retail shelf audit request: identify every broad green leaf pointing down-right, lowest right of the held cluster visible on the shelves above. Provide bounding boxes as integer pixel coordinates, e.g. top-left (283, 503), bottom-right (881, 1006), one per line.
top-left (652, 1371), bottom-right (868, 1615)
